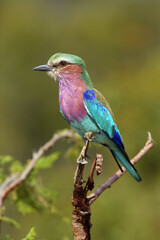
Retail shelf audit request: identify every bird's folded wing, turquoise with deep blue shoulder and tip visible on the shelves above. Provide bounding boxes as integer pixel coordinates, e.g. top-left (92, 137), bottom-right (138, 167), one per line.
top-left (83, 89), bottom-right (124, 149)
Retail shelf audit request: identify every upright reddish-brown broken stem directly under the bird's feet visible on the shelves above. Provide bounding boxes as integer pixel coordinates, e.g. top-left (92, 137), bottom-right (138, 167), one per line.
top-left (72, 133), bottom-right (94, 240)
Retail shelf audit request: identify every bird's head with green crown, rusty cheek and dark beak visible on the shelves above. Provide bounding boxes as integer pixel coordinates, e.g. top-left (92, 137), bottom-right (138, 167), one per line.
top-left (33, 53), bottom-right (92, 86)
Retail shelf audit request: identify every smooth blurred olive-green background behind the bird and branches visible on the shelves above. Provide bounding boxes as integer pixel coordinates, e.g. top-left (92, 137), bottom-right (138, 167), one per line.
top-left (0, 0), bottom-right (160, 240)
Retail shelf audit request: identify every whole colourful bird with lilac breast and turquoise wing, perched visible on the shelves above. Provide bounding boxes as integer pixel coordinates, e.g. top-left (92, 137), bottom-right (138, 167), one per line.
top-left (33, 53), bottom-right (142, 182)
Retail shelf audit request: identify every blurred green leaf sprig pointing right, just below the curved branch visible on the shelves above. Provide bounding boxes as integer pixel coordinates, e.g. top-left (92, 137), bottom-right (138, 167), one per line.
top-left (35, 152), bottom-right (61, 169)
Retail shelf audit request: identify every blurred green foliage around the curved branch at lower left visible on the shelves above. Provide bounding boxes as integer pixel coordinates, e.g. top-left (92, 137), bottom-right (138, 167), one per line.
top-left (0, 152), bottom-right (60, 227)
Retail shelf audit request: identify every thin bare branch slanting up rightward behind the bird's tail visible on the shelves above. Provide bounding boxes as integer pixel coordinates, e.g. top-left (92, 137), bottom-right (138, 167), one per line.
top-left (87, 132), bottom-right (154, 205)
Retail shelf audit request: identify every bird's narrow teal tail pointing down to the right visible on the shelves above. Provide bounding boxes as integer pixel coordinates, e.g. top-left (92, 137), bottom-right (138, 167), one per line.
top-left (111, 150), bottom-right (142, 182)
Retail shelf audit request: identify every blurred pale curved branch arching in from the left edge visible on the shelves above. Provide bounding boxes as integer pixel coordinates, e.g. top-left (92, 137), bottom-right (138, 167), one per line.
top-left (0, 130), bottom-right (76, 208)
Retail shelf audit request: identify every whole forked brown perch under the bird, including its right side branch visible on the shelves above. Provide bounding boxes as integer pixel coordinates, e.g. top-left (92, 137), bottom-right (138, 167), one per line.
top-left (72, 132), bottom-right (154, 240)
